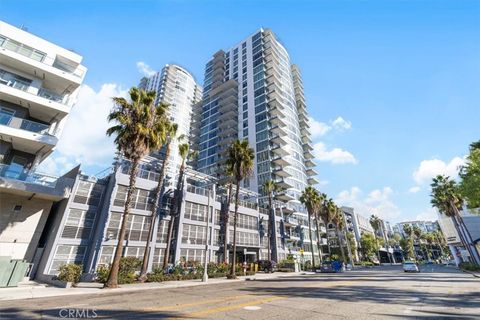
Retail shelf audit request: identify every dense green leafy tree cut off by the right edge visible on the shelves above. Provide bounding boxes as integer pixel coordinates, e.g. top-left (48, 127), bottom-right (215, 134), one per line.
top-left (459, 140), bottom-right (480, 209)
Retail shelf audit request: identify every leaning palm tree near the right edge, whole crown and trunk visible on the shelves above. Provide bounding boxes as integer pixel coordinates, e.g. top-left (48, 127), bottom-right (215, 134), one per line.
top-left (430, 175), bottom-right (477, 262)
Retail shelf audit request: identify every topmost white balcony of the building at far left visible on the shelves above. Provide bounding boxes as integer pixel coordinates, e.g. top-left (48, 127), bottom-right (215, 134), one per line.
top-left (0, 35), bottom-right (86, 89)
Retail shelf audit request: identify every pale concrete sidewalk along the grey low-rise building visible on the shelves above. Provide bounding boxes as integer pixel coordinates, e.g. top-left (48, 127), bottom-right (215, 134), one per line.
top-left (0, 272), bottom-right (300, 301)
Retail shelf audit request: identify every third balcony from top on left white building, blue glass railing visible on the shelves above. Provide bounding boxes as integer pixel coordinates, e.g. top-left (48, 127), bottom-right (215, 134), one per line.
top-left (0, 113), bottom-right (58, 154)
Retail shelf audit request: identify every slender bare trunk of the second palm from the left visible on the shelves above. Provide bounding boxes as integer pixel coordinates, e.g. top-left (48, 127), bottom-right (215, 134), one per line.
top-left (140, 146), bottom-right (170, 280)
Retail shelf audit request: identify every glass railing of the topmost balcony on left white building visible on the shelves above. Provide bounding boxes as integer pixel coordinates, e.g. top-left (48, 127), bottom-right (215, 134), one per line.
top-left (0, 35), bottom-right (84, 78)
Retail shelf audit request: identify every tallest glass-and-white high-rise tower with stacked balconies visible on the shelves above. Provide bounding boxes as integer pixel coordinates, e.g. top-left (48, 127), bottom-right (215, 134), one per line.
top-left (193, 29), bottom-right (318, 260)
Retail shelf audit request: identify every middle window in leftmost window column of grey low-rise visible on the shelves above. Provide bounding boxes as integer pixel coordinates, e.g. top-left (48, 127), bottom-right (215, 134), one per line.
top-left (62, 209), bottom-right (96, 239)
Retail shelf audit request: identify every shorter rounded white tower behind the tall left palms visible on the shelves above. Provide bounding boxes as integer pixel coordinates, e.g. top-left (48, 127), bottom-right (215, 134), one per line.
top-left (139, 64), bottom-right (202, 176)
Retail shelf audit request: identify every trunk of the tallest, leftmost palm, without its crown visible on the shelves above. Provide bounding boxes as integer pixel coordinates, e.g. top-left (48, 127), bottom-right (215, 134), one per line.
top-left (105, 158), bottom-right (140, 288)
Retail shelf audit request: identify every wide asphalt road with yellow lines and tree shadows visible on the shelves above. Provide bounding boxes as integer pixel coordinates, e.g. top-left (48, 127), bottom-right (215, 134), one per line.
top-left (0, 266), bottom-right (480, 320)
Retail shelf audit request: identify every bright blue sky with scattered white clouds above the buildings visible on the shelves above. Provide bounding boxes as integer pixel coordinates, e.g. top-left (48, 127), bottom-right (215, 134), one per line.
top-left (0, 0), bottom-right (480, 222)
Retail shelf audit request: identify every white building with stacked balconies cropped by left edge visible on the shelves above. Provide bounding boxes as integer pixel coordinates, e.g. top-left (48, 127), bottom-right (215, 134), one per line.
top-left (0, 21), bottom-right (88, 261)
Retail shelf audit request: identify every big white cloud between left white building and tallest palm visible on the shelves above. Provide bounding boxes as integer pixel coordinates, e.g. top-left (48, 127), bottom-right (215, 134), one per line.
top-left (39, 84), bottom-right (127, 175)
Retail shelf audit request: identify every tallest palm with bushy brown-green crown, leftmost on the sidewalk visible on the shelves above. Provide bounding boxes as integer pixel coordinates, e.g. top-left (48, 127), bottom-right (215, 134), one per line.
top-left (105, 88), bottom-right (165, 288)
